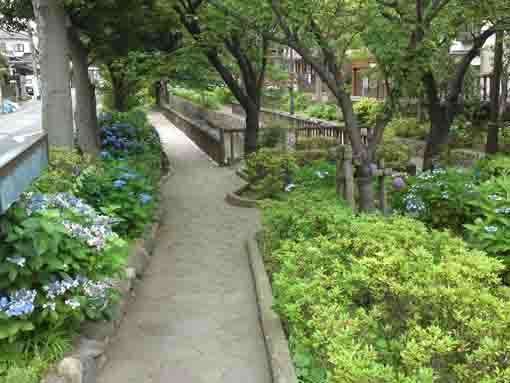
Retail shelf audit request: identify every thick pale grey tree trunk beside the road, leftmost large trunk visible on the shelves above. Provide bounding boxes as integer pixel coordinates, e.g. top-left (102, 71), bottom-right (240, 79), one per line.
top-left (32, 0), bottom-right (74, 150)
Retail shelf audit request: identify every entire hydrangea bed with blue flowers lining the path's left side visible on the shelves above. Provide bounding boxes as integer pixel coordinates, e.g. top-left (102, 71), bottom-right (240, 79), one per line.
top-left (0, 111), bottom-right (161, 383)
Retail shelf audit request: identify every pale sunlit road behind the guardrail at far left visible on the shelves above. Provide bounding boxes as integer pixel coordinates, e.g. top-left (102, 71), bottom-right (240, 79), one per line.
top-left (0, 101), bottom-right (42, 158)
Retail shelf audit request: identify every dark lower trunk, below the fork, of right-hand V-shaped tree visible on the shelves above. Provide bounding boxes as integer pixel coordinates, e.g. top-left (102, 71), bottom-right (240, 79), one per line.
top-left (423, 103), bottom-right (451, 170)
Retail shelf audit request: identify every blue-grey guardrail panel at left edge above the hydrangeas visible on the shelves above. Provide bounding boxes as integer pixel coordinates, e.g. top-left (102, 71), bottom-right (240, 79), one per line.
top-left (0, 133), bottom-right (49, 214)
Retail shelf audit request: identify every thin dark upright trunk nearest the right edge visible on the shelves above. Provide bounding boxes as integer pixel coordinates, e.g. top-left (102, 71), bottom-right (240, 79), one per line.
top-left (486, 31), bottom-right (505, 154)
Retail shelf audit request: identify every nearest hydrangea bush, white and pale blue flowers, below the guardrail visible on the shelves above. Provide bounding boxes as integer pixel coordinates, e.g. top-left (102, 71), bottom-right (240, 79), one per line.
top-left (0, 194), bottom-right (126, 340)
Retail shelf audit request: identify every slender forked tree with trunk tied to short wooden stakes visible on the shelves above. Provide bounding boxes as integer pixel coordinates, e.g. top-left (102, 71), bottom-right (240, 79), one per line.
top-left (265, 0), bottom-right (399, 211)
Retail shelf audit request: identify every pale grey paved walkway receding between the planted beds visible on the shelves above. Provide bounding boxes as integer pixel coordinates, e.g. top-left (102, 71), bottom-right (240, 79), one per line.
top-left (99, 113), bottom-right (271, 383)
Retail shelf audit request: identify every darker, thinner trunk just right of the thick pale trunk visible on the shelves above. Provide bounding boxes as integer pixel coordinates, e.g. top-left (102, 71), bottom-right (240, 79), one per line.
top-left (69, 30), bottom-right (99, 156)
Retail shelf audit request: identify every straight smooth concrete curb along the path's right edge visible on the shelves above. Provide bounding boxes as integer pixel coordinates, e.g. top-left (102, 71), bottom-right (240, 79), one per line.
top-left (245, 238), bottom-right (298, 383)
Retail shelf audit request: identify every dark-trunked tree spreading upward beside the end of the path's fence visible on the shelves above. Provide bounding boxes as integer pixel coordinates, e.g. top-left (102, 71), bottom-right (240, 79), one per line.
top-left (169, 0), bottom-right (269, 154)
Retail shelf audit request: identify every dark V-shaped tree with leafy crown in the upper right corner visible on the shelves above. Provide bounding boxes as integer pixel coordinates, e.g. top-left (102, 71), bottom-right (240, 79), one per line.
top-left (375, 0), bottom-right (509, 168)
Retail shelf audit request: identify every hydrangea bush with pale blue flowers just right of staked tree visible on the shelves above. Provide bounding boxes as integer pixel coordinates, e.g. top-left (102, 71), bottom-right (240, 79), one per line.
top-left (393, 169), bottom-right (477, 233)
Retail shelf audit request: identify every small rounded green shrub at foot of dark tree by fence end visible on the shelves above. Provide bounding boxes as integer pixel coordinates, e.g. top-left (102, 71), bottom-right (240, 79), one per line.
top-left (246, 149), bottom-right (296, 198)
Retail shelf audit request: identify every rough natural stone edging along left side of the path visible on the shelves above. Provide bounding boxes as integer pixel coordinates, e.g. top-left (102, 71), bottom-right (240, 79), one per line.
top-left (42, 151), bottom-right (174, 383)
